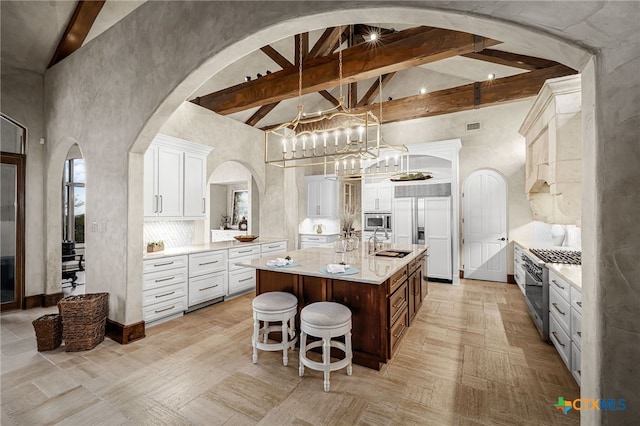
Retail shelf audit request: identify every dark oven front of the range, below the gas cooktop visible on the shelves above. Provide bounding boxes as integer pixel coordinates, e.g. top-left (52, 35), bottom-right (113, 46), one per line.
top-left (522, 252), bottom-right (549, 341)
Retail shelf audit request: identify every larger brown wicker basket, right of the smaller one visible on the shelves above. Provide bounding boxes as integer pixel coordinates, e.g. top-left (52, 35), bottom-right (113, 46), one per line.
top-left (58, 293), bottom-right (109, 352)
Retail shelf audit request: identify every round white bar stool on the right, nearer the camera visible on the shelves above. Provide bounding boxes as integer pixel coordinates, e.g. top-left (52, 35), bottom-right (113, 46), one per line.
top-left (299, 302), bottom-right (353, 392)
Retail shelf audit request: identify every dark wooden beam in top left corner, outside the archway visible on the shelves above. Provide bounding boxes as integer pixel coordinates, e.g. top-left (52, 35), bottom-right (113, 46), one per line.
top-left (47, 0), bottom-right (105, 68)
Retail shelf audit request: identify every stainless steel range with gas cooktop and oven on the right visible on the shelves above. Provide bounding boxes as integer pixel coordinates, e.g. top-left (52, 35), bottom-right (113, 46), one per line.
top-left (522, 249), bottom-right (582, 341)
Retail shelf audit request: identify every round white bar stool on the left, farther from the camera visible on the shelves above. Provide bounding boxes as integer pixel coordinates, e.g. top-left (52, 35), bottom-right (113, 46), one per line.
top-left (251, 291), bottom-right (298, 365)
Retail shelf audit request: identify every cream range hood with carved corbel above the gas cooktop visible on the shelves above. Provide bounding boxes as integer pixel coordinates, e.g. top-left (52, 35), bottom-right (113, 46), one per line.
top-left (519, 75), bottom-right (582, 226)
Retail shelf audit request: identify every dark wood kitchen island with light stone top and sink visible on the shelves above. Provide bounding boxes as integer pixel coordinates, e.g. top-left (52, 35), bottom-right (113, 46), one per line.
top-left (240, 244), bottom-right (428, 370)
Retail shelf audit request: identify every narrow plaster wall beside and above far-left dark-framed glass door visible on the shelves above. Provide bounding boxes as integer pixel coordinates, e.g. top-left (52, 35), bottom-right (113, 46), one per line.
top-left (0, 71), bottom-right (46, 296)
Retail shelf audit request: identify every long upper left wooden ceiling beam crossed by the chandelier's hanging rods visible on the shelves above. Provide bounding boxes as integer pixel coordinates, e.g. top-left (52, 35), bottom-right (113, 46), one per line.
top-left (195, 27), bottom-right (500, 115)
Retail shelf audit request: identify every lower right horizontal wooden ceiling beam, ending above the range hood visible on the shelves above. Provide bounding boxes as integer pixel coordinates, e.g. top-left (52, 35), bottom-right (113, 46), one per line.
top-left (352, 65), bottom-right (577, 123)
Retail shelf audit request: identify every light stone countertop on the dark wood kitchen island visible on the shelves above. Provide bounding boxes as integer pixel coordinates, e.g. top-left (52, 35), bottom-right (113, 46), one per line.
top-left (237, 244), bottom-right (428, 285)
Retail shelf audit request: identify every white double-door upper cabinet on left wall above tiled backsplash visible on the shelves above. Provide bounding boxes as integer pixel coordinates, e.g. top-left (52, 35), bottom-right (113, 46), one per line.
top-left (144, 135), bottom-right (213, 219)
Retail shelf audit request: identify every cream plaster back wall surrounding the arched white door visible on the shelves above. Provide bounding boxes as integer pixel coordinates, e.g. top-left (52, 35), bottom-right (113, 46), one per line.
top-left (383, 99), bottom-right (533, 274)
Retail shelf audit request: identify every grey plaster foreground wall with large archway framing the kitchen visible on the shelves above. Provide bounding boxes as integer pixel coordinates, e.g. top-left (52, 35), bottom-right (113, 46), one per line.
top-left (45, 1), bottom-right (640, 424)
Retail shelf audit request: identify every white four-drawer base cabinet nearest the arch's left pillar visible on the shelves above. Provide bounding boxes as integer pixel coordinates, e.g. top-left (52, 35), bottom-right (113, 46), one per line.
top-left (142, 255), bottom-right (188, 327)
